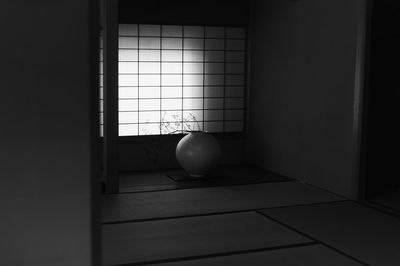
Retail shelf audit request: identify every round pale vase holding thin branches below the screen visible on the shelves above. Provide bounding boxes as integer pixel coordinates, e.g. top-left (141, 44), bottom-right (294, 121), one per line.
top-left (176, 131), bottom-right (221, 178)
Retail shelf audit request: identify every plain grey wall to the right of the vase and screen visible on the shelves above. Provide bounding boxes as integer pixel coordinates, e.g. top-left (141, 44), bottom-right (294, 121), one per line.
top-left (249, 0), bottom-right (365, 198)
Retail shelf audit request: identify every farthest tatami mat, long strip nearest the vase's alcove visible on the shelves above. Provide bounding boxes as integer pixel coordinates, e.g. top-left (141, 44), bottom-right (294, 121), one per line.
top-left (102, 182), bottom-right (343, 223)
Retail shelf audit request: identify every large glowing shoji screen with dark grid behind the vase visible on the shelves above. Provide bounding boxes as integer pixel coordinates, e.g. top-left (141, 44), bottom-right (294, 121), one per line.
top-left (100, 24), bottom-right (246, 136)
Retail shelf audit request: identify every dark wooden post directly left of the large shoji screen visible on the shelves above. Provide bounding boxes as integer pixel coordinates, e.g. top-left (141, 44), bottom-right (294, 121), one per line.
top-left (102, 0), bottom-right (119, 194)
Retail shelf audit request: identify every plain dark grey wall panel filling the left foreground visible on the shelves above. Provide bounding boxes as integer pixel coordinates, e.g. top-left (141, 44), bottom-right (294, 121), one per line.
top-left (0, 0), bottom-right (93, 266)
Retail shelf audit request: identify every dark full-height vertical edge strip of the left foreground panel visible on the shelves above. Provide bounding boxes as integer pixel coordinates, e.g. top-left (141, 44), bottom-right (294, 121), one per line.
top-left (88, 0), bottom-right (101, 266)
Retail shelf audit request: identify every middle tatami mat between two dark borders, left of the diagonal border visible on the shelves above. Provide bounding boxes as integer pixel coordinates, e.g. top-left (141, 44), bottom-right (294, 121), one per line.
top-left (102, 212), bottom-right (313, 265)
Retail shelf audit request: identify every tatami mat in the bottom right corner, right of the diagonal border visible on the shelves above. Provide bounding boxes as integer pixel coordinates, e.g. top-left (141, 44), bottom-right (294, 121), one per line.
top-left (263, 202), bottom-right (400, 266)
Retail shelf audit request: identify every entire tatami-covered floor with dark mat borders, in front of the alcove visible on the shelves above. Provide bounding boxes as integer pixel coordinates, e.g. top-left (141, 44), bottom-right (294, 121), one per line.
top-left (102, 171), bottom-right (400, 266)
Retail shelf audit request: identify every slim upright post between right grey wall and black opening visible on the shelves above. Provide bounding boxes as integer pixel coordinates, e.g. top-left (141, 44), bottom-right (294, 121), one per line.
top-left (357, 0), bottom-right (374, 202)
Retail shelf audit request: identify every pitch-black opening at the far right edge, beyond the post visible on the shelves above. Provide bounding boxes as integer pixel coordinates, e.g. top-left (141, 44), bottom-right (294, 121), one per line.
top-left (366, 0), bottom-right (400, 194)
